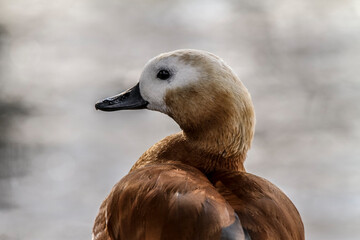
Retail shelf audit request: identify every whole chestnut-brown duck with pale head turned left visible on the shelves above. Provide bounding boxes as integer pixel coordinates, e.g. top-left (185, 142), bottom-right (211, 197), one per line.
top-left (92, 49), bottom-right (305, 240)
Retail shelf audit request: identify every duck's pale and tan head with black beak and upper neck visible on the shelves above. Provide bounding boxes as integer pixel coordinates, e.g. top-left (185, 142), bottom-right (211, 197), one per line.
top-left (95, 50), bottom-right (255, 160)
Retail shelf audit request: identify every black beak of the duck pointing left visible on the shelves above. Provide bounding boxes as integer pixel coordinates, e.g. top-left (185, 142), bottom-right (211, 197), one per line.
top-left (95, 83), bottom-right (148, 112)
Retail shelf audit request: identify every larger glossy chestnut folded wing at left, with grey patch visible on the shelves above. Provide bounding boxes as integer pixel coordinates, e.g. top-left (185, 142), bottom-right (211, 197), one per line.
top-left (93, 163), bottom-right (249, 240)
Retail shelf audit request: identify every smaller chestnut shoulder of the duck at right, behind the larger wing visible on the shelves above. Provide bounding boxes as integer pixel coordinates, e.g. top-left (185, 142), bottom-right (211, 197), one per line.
top-left (209, 170), bottom-right (305, 240)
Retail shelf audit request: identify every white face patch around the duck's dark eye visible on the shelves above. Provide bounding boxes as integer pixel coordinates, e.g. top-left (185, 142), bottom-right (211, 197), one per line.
top-left (139, 56), bottom-right (200, 113)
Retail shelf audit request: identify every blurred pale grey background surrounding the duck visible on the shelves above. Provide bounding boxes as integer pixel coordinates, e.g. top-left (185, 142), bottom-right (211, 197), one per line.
top-left (0, 0), bottom-right (360, 240)
